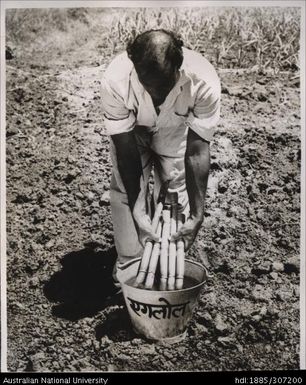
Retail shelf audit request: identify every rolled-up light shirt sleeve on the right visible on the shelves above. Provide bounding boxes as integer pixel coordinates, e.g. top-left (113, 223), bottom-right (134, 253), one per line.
top-left (186, 82), bottom-right (221, 142)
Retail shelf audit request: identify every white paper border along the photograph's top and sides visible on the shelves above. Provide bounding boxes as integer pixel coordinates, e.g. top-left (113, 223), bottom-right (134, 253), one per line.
top-left (0, 0), bottom-right (306, 372)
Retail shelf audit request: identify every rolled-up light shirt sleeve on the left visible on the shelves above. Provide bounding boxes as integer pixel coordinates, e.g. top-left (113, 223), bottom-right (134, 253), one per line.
top-left (101, 78), bottom-right (136, 135)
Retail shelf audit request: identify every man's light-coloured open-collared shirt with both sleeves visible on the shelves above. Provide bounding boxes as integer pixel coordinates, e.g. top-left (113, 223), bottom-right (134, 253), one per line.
top-left (101, 48), bottom-right (221, 141)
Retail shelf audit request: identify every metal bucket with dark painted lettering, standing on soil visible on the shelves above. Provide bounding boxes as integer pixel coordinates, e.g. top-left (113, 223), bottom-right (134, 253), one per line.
top-left (117, 258), bottom-right (207, 343)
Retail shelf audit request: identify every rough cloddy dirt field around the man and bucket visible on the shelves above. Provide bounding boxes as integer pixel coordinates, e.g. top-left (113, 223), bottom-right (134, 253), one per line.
top-left (6, 7), bottom-right (301, 372)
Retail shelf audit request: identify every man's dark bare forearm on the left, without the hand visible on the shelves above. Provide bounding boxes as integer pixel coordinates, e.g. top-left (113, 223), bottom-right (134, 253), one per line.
top-left (111, 131), bottom-right (142, 211)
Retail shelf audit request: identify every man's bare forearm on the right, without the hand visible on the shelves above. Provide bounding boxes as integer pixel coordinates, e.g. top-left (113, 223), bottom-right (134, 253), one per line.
top-left (185, 129), bottom-right (210, 222)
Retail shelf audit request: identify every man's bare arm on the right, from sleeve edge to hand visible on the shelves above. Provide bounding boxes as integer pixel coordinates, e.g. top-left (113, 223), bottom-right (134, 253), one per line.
top-left (172, 129), bottom-right (210, 250)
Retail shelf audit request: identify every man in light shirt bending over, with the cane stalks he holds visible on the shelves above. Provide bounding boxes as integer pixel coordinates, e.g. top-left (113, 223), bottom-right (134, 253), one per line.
top-left (101, 29), bottom-right (221, 290)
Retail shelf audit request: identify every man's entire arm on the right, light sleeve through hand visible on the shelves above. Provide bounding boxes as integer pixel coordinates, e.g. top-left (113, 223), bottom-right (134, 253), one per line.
top-left (172, 62), bottom-right (221, 250)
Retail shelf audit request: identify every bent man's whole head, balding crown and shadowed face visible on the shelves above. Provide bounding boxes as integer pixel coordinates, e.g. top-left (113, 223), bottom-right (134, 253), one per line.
top-left (127, 29), bottom-right (183, 101)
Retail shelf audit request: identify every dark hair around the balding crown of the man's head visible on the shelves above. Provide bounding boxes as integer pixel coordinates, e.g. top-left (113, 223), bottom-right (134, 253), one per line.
top-left (127, 29), bottom-right (183, 72)
